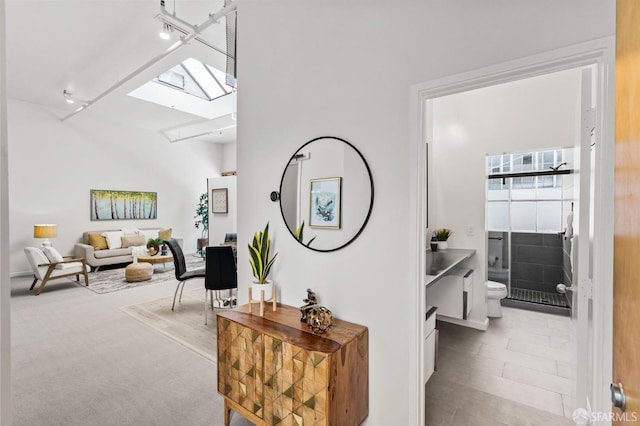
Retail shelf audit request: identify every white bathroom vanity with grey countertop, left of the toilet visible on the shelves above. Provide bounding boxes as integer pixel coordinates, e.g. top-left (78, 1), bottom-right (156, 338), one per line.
top-left (422, 249), bottom-right (475, 383)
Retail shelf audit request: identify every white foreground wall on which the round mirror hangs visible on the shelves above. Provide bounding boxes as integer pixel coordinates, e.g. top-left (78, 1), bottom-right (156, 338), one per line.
top-left (237, 0), bottom-right (615, 425)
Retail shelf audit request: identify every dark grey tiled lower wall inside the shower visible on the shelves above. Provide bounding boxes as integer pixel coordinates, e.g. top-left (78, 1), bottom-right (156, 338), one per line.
top-left (511, 232), bottom-right (571, 293)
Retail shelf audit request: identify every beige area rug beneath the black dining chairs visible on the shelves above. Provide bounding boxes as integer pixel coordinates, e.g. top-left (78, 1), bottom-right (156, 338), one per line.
top-left (120, 288), bottom-right (224, 362)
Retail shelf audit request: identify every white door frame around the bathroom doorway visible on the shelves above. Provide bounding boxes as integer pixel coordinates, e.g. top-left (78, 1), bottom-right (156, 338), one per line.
top-left (408, 36), bottom-right (615, 424)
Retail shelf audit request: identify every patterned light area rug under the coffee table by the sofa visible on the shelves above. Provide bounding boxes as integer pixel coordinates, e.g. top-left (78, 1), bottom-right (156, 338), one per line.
top-left (75, 256), bottom-right (204, 294)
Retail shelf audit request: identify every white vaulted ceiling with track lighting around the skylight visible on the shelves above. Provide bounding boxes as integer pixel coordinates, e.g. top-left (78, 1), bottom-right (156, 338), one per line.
top-left (6, 0), bottom-right (235, 143)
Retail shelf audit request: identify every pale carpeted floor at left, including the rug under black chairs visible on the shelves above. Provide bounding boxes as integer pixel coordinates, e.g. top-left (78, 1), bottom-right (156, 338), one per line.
top-left (11, 272), bottom-right (251, 426)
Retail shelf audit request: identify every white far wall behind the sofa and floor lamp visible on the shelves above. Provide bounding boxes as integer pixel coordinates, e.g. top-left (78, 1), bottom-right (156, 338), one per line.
top-left (9, 100), bottom-right (223, 275)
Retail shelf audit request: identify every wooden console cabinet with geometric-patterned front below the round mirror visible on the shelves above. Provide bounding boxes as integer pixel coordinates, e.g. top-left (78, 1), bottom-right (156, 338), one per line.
top-left (217, 304), bottom-right (369, 426)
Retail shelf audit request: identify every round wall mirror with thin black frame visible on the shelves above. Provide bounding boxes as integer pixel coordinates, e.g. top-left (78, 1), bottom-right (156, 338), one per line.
top-left (280, 136), bottom-right (373, 251)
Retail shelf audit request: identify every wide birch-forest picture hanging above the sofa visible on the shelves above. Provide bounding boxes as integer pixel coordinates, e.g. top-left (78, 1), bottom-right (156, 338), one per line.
top-left (90, 189), bottom-right (158, 220)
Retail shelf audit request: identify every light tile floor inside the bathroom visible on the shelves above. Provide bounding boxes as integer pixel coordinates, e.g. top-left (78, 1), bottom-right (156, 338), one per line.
top-left (426, 307), bottom-right (575, 426)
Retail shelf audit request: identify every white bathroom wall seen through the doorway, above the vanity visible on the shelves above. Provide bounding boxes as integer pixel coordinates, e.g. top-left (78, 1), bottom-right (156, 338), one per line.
top-left (429, 70), bottom-right (580, 323)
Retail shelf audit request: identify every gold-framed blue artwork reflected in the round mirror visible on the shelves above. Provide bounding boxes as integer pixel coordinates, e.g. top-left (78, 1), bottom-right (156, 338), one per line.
top-left (309, 177), bottom-right (342, 229)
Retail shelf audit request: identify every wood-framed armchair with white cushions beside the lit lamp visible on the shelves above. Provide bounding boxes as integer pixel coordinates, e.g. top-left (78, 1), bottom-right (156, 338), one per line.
top-left (24, 247), bottom-right (89, 296)
